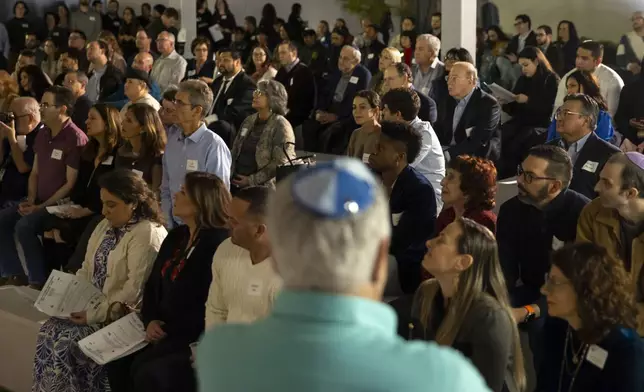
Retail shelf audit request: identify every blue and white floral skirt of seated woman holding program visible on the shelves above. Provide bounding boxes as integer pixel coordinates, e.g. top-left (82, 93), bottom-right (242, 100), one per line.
top-left (31, 318), bottom-right (110, 392)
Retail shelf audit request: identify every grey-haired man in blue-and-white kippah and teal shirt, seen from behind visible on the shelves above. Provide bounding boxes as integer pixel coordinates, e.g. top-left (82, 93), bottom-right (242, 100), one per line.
top-left (197, 158), bottom-right (488, 392)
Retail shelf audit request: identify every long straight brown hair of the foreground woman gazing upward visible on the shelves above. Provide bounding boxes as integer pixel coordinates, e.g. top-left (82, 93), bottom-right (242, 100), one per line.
top-left (418, 218), bottom-right (526, 391)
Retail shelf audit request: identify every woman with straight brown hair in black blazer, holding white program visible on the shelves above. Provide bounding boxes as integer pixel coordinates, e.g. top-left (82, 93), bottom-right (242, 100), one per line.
top-left (122, 172), bottom-right (231, 392)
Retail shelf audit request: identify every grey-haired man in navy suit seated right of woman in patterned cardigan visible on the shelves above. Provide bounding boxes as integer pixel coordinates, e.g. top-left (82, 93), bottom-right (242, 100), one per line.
top-left (302, 45), bottom-right (371, 152)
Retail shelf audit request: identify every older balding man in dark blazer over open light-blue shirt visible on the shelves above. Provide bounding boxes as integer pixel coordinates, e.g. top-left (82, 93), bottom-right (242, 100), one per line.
top-left (434, 62), bottom-right (501, 162)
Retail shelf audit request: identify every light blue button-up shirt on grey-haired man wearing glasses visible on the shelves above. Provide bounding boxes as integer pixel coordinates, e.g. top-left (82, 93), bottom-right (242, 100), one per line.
top-left (161, 123), bottom-right (232, 228)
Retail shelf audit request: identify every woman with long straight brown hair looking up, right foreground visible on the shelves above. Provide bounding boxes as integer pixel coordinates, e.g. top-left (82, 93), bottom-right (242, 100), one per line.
top-left (409, 218), bottom-right (526, 392)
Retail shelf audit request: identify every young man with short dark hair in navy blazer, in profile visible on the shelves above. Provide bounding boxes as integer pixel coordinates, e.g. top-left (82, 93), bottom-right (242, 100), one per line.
top-left (369, 121), bottom-right (436, 293)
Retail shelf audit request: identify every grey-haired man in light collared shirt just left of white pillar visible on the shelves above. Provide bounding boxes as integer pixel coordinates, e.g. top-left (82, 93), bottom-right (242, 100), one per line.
top-left (413, 34), bottom-right (445, 96)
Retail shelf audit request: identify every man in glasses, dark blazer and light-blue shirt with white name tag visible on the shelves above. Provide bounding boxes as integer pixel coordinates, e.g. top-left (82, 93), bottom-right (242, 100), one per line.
top-left (548, 94), bottom-right (620, 200)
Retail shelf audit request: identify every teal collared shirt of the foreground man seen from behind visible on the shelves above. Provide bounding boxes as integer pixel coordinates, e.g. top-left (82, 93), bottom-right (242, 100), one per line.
top-left (197, 290), bottom-right (489, 392)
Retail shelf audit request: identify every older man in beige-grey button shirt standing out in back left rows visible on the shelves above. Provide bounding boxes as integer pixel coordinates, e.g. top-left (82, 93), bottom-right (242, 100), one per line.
top-left (150, 31), bottom-right (187, 92)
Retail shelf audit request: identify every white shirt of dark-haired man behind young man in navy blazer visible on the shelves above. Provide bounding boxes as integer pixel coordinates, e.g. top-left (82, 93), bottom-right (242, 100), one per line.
top-left (409, 117), bottom-right (445, 213)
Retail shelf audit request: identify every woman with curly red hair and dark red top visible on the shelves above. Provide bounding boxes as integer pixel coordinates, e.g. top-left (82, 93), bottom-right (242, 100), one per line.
top-left (435, 155), bottom-right (496, 235)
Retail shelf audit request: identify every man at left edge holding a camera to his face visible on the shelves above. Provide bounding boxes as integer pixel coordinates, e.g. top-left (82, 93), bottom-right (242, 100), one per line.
top-left (0, 97), bottom-right (43, 210)
